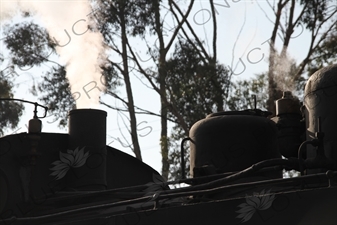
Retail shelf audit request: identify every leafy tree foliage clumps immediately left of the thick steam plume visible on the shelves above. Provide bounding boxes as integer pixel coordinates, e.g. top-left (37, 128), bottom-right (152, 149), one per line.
top-left (4, 21), bottom-right (74, 126)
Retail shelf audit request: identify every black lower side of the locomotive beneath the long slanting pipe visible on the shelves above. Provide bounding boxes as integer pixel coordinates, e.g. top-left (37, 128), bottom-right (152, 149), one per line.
top-left (0, 172), bottom-right (337, 225)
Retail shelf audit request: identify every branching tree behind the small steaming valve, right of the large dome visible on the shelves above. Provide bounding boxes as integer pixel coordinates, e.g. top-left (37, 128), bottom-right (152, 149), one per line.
top-left (261, 0), bottom-right (337, 114)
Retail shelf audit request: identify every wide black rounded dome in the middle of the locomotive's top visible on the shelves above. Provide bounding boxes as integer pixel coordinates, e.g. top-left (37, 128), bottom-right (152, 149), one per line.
top-left (189, 115), bottom-right (281, 177)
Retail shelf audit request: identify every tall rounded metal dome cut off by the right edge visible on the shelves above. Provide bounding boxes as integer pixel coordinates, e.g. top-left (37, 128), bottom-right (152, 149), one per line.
top-left (304, 65), bottom-right (337, 173)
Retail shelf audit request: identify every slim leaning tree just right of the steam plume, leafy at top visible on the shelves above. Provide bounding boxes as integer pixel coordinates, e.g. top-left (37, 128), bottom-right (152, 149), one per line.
top-left (89, 0), bottom-right (158, 160)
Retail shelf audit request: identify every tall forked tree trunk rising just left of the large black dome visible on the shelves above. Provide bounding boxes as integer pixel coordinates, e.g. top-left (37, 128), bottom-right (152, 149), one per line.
top-left (117, 0), bottom-right (200, 180)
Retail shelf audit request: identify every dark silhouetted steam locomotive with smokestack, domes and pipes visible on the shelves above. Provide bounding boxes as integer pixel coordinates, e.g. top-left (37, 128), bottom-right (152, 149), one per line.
top-left (0, 65), bottom-right (337, 225)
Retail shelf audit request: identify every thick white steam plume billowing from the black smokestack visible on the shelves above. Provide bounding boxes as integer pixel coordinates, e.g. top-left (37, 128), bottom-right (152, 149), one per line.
top-left (0, 0), bottom-right (106, 108)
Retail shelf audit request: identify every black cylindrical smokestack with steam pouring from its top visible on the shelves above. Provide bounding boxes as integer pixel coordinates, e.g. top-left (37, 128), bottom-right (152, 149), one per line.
top-left (66, 109), bottom-right (107, 190)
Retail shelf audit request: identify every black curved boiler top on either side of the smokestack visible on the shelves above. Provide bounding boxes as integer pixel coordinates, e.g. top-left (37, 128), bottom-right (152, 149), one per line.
top-left (0, 133), bottom-right (163, 220)
